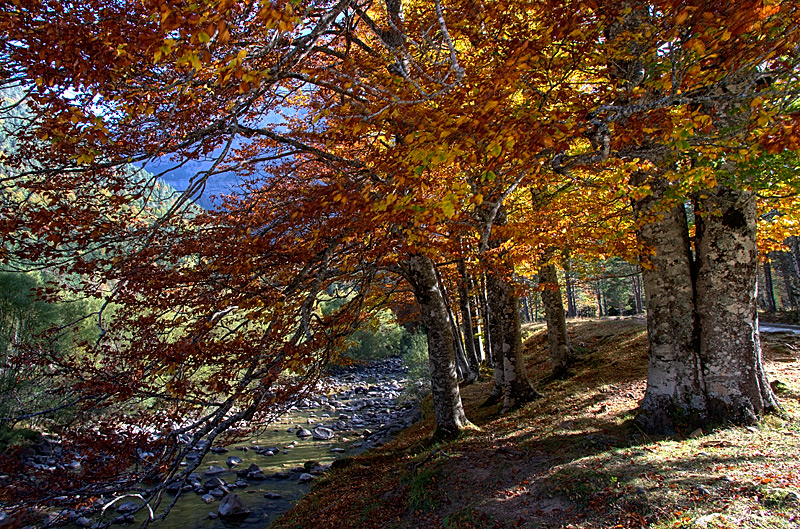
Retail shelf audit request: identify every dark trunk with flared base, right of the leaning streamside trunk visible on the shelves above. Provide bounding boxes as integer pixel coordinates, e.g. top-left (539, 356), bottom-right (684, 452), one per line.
top-left (486, 271), bottom-right (541, 413)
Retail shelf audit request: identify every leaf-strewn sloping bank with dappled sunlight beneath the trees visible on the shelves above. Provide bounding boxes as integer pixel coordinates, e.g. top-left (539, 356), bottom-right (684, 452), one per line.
top-left (271, 318), bottom-right (800, 529)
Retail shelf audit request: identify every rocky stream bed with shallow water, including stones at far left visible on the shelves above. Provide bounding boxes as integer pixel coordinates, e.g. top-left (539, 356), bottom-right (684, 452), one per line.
top-left (12, 358), bottom-right (420, 529)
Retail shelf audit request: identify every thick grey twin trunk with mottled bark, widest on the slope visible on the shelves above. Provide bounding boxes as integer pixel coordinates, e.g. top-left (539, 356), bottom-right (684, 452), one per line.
top-left (632, 174), bottom-right (778, 433)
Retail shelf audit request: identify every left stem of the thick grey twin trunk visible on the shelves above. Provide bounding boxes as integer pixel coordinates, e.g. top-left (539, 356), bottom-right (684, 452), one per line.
top-left (632, 173), bottom-right (707, 433)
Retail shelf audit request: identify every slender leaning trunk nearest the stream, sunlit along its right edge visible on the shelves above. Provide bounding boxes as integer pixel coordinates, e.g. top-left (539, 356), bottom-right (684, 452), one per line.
top-left (401, 255), bottom-right (469, 438)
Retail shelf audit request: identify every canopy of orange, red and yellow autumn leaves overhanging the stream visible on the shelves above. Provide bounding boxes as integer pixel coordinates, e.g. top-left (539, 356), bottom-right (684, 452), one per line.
top-left (0, 0), bottom-right (800, 520)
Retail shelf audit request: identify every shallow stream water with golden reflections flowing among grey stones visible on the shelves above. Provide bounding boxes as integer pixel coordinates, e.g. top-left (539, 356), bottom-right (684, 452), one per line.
top-left (88, 359), bottom-right (418, 529)
